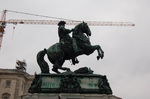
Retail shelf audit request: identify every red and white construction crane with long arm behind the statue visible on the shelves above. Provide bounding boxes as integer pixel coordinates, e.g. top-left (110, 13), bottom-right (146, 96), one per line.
top-left (0, 10), bottom-right (135, 48)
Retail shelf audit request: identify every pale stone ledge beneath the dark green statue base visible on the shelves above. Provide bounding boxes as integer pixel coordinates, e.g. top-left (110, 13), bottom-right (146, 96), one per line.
top-left (23, 93), bottom-right (121, 99)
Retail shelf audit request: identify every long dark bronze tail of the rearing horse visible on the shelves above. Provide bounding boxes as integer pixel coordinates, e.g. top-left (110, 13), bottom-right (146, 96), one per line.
top-left (37, 49), bottom-right (49, 73)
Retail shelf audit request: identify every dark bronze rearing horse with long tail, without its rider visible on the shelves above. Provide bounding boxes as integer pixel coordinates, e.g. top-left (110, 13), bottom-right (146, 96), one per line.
top-left (37, 22), bottom-right (104, 73)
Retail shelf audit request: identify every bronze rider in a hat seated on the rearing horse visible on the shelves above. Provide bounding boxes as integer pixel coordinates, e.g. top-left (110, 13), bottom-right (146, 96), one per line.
top-left (58, 21), bottom-right (79, 65)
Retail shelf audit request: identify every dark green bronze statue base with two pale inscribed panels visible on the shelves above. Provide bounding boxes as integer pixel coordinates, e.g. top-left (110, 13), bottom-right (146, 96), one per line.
top-left (29, 72), bottom-right (112, 94)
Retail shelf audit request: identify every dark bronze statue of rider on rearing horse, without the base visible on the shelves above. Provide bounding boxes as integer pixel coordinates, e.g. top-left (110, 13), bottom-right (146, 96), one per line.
top-left (37, 21), bottom-right (104, 73)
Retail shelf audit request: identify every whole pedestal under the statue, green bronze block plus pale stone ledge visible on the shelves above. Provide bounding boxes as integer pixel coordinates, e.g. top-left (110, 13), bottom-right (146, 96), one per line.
top-left (25, 72), bottom-right (121, 99)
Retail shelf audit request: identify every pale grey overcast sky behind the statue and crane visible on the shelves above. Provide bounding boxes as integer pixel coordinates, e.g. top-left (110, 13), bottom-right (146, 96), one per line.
top-left (0, 0), bottom-right (150, 99)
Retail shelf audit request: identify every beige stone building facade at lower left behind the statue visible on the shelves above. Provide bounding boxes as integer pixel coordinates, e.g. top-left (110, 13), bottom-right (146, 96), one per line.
top-left (0, 69), bottom-right (34, 99)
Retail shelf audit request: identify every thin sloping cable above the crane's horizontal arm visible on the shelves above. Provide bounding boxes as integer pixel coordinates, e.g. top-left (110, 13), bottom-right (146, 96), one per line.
top-left (6, 10), bottom-right (80, 22)
